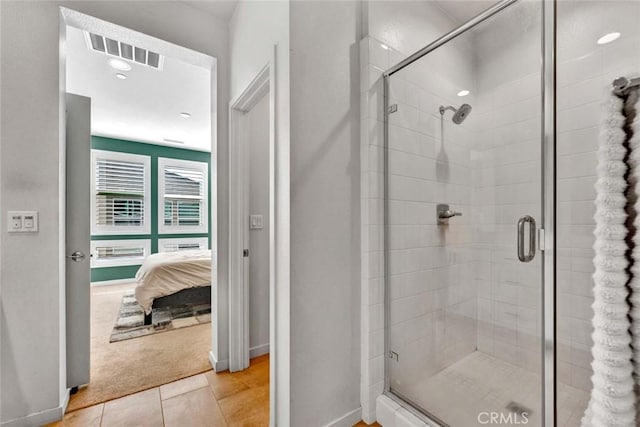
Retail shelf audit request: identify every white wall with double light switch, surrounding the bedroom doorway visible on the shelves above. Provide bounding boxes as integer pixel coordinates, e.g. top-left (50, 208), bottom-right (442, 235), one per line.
top-left (0, 1), bottom-right (229, 425)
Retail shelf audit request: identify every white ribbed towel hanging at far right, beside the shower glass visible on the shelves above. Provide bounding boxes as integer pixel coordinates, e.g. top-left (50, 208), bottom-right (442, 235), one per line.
top-left (582, 94), bottom-right (636, 427)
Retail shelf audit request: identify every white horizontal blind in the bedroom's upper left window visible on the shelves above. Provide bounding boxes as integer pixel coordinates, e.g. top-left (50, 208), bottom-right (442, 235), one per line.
top-left (95, 158), bottom-right (146, 227)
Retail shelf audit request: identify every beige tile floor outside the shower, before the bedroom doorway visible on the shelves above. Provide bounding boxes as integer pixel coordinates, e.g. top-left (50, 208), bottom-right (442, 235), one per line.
top-left (49, 355), bottom-right (269, 427)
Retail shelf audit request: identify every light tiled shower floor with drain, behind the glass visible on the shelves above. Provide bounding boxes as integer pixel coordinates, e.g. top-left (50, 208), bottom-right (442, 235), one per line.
top-left (384, 351), bottom-right (589, 427)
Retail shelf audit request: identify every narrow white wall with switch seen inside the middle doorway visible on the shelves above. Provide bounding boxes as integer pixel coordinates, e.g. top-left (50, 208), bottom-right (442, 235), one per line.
top-left (247, 94), bottom-right (270, 355)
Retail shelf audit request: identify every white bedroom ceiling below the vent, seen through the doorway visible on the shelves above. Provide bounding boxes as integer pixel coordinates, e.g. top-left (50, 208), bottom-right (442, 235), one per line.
top-left (67, 26), bottom-right (211, 151)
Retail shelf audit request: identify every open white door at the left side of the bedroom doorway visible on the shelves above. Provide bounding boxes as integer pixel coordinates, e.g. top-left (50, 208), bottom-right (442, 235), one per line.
top-left (65, 94), bottom-right (91, 388)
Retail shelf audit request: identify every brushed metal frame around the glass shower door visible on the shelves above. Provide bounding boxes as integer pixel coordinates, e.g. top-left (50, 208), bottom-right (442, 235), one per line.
top-left (382, 0), bottom-right (557, 427)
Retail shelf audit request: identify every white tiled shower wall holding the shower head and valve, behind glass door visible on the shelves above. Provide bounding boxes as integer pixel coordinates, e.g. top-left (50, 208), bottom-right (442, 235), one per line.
top-left (388, 35), bottom-right (477, 397)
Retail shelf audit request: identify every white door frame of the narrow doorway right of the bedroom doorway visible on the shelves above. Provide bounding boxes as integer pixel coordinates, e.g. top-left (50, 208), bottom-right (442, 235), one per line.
top-left (229, 53), bottom-right (276, 372)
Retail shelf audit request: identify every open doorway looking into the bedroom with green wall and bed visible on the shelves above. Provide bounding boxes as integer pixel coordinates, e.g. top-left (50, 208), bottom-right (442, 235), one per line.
top-left (63, 10), bottom-right (216, 411)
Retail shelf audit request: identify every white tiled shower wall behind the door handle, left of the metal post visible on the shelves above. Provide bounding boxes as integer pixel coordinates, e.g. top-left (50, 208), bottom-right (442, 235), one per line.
top-left (469, 2), bottom-right (542, 372)
